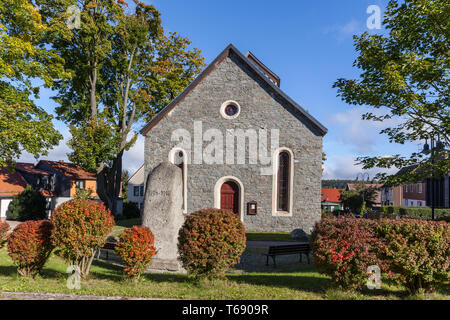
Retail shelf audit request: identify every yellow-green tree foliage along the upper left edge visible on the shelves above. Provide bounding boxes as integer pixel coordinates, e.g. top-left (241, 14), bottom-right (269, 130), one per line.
top-left (0, 0), bottom-right (68, 166)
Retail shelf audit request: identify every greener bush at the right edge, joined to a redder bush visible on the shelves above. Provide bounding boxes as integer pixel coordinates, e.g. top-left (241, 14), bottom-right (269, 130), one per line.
top-left (376, 219), bottom-right (450, 293)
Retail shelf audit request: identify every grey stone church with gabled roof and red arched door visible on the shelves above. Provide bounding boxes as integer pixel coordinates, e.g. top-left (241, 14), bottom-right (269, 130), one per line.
top-left (141, 44), bottom-right (327, 232)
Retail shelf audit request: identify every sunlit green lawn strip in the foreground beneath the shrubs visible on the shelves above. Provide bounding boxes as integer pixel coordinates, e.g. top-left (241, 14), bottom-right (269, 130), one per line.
top-left (0, 248), bottom-right (450, 300)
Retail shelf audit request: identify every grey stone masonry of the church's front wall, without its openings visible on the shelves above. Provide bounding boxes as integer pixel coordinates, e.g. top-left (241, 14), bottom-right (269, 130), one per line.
top-left (145, 54), bottom-right (322, 232)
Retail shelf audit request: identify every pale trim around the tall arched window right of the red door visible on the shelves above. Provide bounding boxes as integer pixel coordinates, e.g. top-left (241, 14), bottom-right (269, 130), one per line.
top-left (272, 147), bottom-right (295, 217)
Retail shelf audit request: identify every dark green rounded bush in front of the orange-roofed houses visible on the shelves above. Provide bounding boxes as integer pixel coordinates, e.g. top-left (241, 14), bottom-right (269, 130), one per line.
top-left (7, 185), bottom-right (47, 221)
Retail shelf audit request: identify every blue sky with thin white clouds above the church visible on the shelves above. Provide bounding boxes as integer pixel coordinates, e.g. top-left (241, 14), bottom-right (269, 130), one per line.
top-left (21, 0), bottom-right (419, 179)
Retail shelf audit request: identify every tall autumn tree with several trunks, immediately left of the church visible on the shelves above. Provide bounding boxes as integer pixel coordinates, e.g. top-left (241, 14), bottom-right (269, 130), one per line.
top-left (36, 0), bottom-right (204, 214)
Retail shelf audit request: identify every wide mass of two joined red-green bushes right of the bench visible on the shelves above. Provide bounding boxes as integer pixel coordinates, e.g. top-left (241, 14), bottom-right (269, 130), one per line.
top-left (312, 217), bottom-right (450, 293)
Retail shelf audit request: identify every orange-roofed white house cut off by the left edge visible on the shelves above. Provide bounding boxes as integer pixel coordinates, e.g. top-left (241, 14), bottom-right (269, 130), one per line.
top-left (0, 167), bottom-right (27, 219)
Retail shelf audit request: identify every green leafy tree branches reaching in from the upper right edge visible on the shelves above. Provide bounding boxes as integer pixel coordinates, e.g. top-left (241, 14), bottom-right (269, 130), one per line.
top-left (333, 0), bottom-right (450, 186)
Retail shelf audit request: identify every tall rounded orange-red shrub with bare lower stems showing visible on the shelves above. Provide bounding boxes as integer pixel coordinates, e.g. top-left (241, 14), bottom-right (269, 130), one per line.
top-left (52, 199), bottom-right (114, 278)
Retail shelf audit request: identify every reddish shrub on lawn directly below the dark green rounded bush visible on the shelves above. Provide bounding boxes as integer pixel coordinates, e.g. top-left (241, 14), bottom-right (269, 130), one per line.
top-left (8, 220), bottom-right (53, 277)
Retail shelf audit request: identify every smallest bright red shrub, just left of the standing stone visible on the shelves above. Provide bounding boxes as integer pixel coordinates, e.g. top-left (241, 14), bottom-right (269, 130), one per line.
top-left (115, 226), bottom-right (156, 280)
